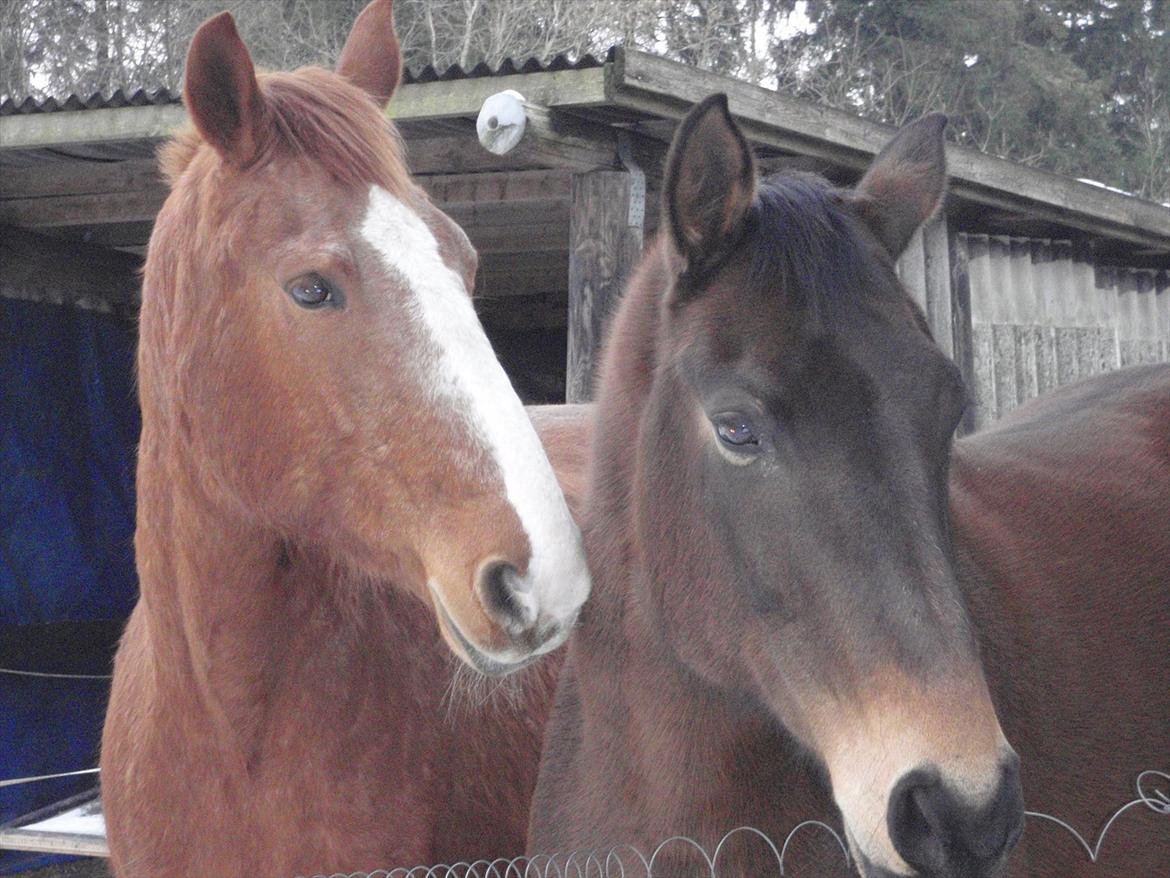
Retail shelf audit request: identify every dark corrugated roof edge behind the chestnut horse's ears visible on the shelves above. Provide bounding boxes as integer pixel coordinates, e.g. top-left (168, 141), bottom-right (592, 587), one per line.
top-left (0, 48), bottom-right (613, 116)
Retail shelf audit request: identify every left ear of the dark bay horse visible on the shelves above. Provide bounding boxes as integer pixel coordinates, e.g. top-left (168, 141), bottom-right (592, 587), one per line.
top-left (663, 95), bottom-right (756, 268)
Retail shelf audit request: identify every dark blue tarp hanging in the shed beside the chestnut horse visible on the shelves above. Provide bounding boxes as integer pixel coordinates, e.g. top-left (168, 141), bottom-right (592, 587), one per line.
top-left (0, 300), bottom-right (139, 873)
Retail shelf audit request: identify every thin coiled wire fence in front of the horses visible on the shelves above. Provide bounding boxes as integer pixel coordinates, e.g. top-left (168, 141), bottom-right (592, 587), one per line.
top-left (297, 770), bottom-right (1170, 878)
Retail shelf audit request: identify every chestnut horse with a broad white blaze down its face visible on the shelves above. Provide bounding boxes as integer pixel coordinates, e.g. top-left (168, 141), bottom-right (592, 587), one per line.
top-left (101, 0), bottom-right (589, 878)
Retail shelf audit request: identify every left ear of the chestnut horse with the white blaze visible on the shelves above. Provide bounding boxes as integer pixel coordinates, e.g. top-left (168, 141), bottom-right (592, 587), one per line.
top-left (183, 12), bottom-right (268, 167)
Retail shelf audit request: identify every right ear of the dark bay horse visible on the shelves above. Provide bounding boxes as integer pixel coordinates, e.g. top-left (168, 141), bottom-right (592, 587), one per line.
top-left (849, 112), bottom-right (947, 259)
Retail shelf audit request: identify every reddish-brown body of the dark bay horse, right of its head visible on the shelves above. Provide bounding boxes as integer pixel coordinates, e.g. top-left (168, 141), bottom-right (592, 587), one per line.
top-left (950, 366), bottom-right (1170, 878)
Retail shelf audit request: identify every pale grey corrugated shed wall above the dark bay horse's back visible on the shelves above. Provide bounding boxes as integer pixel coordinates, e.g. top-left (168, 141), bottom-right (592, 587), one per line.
top-left (899, 226), bottom-right (1170, 430)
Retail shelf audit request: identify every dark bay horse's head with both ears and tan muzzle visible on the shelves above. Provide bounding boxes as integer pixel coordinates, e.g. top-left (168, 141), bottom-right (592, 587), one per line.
top-left (634, 96), bottom-right (1023, 878)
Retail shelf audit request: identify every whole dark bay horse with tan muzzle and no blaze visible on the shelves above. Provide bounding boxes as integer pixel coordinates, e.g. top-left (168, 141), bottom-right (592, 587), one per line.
top-left (529, 96), bottom-right (1170, 878)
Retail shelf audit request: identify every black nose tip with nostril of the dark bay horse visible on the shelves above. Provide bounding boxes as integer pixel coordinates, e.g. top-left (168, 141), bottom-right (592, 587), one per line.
top-left (887, 756), bottom-right (1024, 878)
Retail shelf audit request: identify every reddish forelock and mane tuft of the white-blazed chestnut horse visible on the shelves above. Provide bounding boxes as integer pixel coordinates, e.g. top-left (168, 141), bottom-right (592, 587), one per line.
top-left (159, 67), bottom-right (412, 196)
